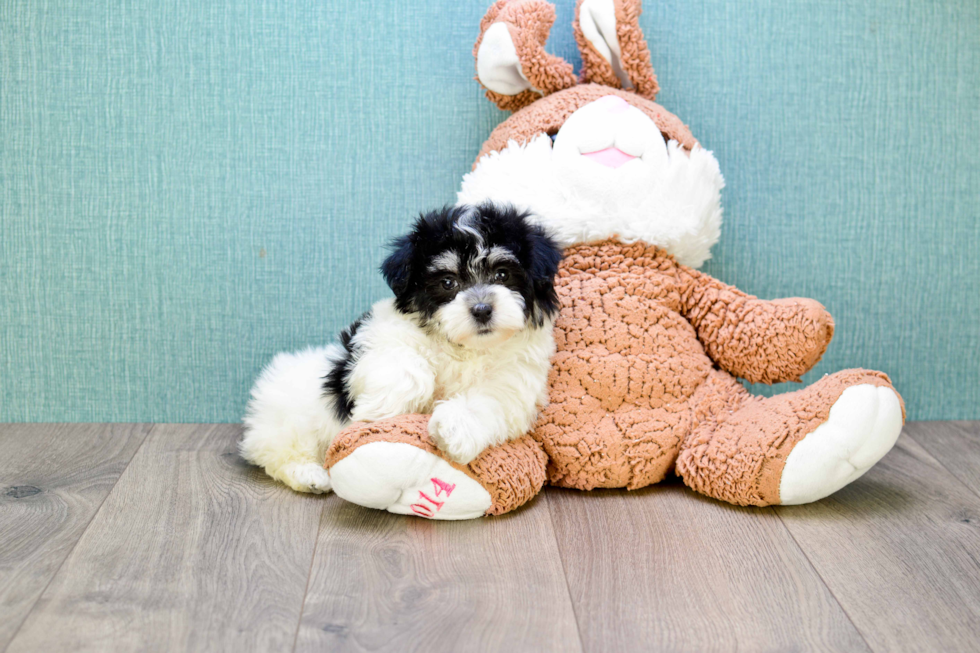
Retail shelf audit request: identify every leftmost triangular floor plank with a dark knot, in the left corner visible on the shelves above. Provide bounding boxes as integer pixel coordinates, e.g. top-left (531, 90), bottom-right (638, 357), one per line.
top-left (0, 424), bottom-right (150, 650)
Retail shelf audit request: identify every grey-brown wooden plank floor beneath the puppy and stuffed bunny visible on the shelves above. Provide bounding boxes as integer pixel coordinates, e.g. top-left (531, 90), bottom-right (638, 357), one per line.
top-left (0, 422), bottom-right (980, 653)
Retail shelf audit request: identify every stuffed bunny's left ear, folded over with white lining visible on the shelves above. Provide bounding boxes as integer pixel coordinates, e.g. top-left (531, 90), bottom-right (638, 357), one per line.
top-left (473, 0), bottom-right (577, 111)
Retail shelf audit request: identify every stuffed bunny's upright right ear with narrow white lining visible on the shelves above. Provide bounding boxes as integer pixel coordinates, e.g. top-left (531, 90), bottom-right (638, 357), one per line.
top-left (574, 0), bottom-right (660, 100)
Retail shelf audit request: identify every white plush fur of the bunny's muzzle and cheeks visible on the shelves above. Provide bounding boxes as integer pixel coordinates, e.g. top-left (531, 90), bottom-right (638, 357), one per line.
top-left (458, 98), bottom-right (725, 267)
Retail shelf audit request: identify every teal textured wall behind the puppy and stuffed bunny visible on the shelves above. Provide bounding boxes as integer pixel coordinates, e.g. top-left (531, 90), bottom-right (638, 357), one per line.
top-left (0, 0), bottom-right (980, 421)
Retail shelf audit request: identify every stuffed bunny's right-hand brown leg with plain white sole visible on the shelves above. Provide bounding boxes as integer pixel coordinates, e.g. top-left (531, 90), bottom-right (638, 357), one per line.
top-left (677, 370), bottom-right (904, 506)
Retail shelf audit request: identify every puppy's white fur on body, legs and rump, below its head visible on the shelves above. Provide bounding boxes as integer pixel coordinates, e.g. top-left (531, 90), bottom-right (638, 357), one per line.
top-left (241, 298), bottom-right (554, 492)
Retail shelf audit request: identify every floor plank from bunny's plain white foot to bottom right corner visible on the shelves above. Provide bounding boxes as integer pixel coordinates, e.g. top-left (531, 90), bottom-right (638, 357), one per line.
top-left (777, 434), bottom-right (980, 651)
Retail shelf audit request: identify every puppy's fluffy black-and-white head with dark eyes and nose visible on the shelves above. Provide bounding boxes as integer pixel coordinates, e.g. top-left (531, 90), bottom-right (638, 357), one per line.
top-left (381, 202), bottom-right (562, 349)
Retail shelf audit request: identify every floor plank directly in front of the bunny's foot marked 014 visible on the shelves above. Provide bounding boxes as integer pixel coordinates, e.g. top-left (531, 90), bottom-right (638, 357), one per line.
top-left (297, 496), bottom-right (581, 653)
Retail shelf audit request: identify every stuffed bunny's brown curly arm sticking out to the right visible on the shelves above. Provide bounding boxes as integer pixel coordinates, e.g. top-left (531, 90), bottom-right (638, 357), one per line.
top-left (677, 265), bottom-right (834, 384)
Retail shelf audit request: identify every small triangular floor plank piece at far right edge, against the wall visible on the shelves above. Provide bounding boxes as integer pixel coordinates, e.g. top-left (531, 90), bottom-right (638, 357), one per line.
top-left (904, 422), bottom-right (980, 496)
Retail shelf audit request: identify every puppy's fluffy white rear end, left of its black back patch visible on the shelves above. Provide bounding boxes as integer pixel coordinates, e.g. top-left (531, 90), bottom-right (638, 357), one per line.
top-left (239, 344), bottom-right (343, 493)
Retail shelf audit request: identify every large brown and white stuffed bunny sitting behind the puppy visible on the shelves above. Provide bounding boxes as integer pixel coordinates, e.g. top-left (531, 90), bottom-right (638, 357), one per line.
top-left (325, 0), bottom-right (904, 519)
